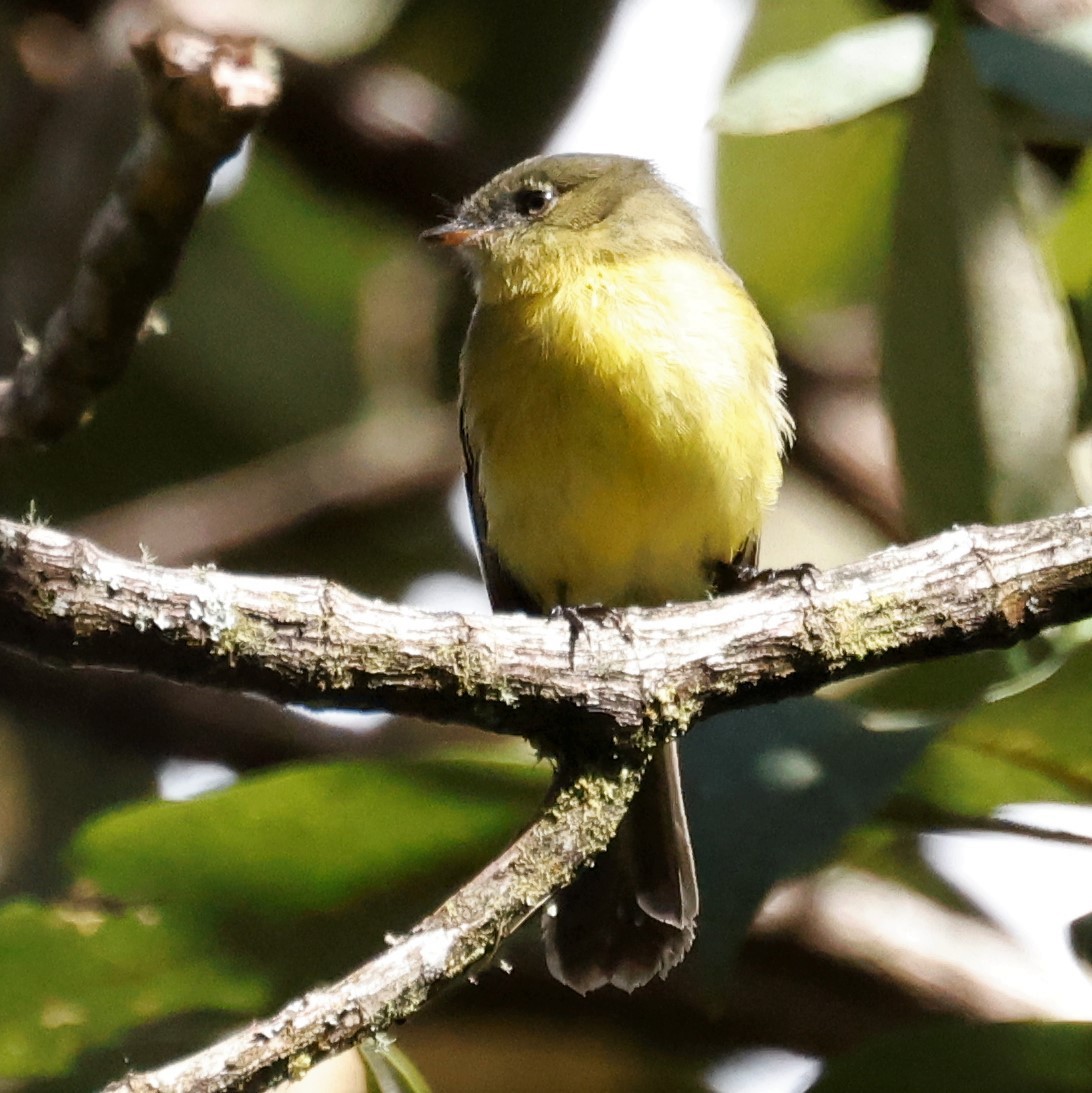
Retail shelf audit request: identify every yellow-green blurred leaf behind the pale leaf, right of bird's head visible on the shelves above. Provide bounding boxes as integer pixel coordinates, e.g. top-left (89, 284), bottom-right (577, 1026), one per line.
top-left (717, 0), bottom-right (904, 338)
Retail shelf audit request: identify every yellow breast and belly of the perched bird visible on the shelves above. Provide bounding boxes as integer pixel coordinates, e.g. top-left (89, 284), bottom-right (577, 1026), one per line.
top-left (463, 256), bottom-right (789, 606)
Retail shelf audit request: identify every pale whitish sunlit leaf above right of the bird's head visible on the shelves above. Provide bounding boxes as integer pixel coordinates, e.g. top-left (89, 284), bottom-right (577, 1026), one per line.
top-left (712, 15), bottom-right (934, 136)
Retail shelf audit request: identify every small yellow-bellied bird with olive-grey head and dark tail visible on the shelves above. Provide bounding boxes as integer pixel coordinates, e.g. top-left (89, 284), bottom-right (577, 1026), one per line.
top-left (425, 155), bottom-right (792, 994)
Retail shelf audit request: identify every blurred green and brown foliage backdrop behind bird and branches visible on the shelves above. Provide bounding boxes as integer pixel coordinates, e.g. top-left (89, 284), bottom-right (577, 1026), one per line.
top-left (0, 0), bottom-right (1092, 1093)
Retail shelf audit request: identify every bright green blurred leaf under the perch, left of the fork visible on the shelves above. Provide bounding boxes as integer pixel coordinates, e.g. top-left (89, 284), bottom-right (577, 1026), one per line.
top-left (72, 762), bottom-right (545, 918)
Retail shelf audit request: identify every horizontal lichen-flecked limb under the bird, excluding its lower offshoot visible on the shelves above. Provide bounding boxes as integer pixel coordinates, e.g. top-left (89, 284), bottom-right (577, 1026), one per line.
top-left (0, 509), bottom-right (1092, 753)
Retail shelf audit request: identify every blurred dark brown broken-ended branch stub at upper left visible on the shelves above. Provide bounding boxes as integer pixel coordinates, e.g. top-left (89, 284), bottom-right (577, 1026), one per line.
top-left (0, 31), bottom-right (280, 443)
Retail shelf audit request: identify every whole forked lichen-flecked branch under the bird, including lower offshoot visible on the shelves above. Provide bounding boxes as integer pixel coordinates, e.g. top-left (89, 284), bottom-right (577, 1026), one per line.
top-left (0, 509), bottom-right (1092, 1093)
